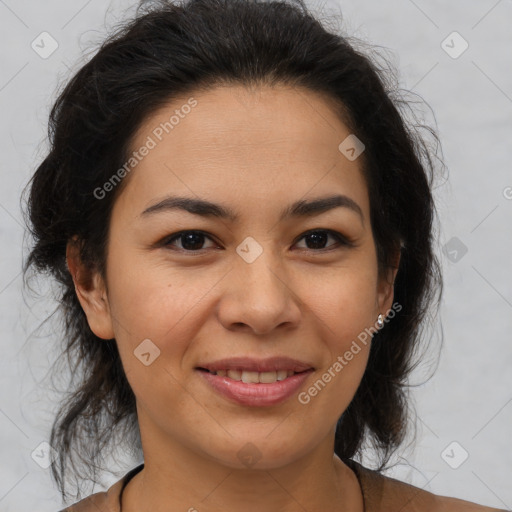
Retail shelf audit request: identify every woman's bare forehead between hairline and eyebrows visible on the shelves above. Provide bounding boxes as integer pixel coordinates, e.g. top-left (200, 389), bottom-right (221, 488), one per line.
top-left (113, 85), bottom-right (368, 220)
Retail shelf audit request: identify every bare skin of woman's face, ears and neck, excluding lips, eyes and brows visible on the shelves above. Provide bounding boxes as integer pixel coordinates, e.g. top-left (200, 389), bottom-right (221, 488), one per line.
top-left (67, 86), bottom-right (395, 512)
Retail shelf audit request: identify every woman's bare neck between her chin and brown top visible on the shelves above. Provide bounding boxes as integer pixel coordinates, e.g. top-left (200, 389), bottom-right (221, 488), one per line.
top-left (122, 414), bottom-right (363, 512)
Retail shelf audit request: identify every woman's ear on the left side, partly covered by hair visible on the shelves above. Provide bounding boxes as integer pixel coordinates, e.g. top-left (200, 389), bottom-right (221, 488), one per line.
top-left (66, 237), bottom-right (114, 340)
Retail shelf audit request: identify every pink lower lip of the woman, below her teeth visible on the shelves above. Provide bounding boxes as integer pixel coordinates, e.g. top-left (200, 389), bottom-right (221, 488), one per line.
top-left (197, 370), bottom-right (313, 407)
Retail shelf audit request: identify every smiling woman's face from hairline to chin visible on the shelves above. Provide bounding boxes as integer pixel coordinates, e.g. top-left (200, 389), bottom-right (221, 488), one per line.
top-left (75, 86), bottom-right (392, 468)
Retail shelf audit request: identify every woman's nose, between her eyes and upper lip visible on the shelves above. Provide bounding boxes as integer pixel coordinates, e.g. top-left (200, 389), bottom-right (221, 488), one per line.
top-left (217, 251), bottom-right (301, 336)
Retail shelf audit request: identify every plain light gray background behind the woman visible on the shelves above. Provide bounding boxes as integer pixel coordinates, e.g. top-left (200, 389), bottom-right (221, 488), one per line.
top-left (0, 0), bottom-right (512, 512)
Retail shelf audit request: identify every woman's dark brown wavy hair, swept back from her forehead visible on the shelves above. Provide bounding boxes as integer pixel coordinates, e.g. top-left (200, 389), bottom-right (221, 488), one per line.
top-left (25, 0), bottom-right (441, 497)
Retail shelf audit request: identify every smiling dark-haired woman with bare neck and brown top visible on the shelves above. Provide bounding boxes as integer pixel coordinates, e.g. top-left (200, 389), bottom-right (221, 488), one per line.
top-left (23, 0), bottom-right (508, 512)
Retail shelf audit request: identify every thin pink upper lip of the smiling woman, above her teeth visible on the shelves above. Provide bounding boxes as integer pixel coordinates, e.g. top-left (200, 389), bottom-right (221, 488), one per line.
top-left (197, 356), bottom-right (313, 372)
